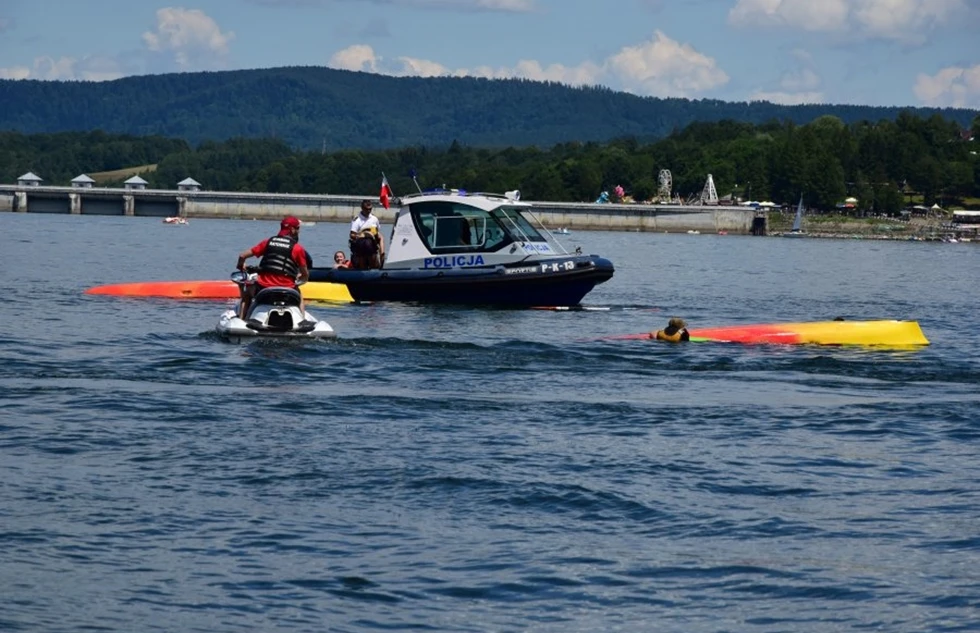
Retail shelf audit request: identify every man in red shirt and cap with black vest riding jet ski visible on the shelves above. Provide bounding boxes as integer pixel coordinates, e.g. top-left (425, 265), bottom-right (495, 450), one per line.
top-left (238, 215), bottom-right (310, 319)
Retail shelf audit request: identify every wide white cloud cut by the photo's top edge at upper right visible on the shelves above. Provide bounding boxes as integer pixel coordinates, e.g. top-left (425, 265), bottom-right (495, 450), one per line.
top-left (728, 0), bottom-right (970, 42)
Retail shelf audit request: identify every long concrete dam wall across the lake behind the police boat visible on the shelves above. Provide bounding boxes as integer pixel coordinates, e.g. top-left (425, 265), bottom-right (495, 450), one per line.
top-left (0, 185), bottom-right (765, 235)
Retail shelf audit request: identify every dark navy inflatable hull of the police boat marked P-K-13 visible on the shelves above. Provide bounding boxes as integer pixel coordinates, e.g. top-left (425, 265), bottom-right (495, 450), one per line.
top-left (310, 256), bottom-right (614, 307)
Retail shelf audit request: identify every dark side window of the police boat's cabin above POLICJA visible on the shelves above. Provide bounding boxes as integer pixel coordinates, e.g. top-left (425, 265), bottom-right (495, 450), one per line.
top-left (412, 202), bottom-right (514, 253)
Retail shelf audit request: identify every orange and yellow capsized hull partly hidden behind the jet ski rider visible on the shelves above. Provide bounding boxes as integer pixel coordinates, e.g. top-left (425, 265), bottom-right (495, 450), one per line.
top-left (85, 280), bottom-right (353, 303)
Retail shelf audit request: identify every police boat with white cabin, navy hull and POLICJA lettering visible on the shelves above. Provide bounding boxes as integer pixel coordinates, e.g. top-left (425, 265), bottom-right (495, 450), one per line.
top-left (310, 189), bottom-right (614, 307)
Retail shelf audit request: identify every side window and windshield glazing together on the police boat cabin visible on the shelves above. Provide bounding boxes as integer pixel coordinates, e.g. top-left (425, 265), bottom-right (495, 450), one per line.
top-left (412, 201), bottom-right (546, 253)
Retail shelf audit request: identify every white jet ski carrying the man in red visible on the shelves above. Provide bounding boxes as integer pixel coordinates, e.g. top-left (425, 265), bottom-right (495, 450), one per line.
top-left (215, 267), bottom-right (337, 343)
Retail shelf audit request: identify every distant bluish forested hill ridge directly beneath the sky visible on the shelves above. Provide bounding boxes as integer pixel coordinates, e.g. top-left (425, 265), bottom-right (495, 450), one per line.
top-left (0, 67), bottom-right (977, 150)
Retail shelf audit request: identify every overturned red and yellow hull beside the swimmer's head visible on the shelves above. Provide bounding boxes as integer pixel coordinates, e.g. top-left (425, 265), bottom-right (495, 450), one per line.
top-left (690, 320), bottom-right (929, 347)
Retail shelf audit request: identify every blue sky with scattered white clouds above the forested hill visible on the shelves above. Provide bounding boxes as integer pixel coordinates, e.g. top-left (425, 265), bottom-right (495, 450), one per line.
top-left (0, 0), bottom-right (980, 109)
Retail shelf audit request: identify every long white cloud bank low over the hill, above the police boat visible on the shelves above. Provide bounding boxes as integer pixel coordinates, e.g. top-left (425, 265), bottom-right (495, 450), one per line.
top-left (328, 31), bottom-right (729, 97)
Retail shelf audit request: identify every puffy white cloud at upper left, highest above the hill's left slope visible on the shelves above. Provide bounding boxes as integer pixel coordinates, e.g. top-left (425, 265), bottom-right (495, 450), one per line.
top-left (143, 7), bottom-right (235, 70)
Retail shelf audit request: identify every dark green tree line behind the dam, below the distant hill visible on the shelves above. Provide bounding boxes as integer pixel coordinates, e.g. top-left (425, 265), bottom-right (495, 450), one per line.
top-left (0, 112), bottom-right (980, 213)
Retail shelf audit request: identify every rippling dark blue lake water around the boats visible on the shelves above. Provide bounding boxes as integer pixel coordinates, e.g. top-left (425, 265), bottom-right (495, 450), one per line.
top-left (0, 213), bottom-right (980, 633)
